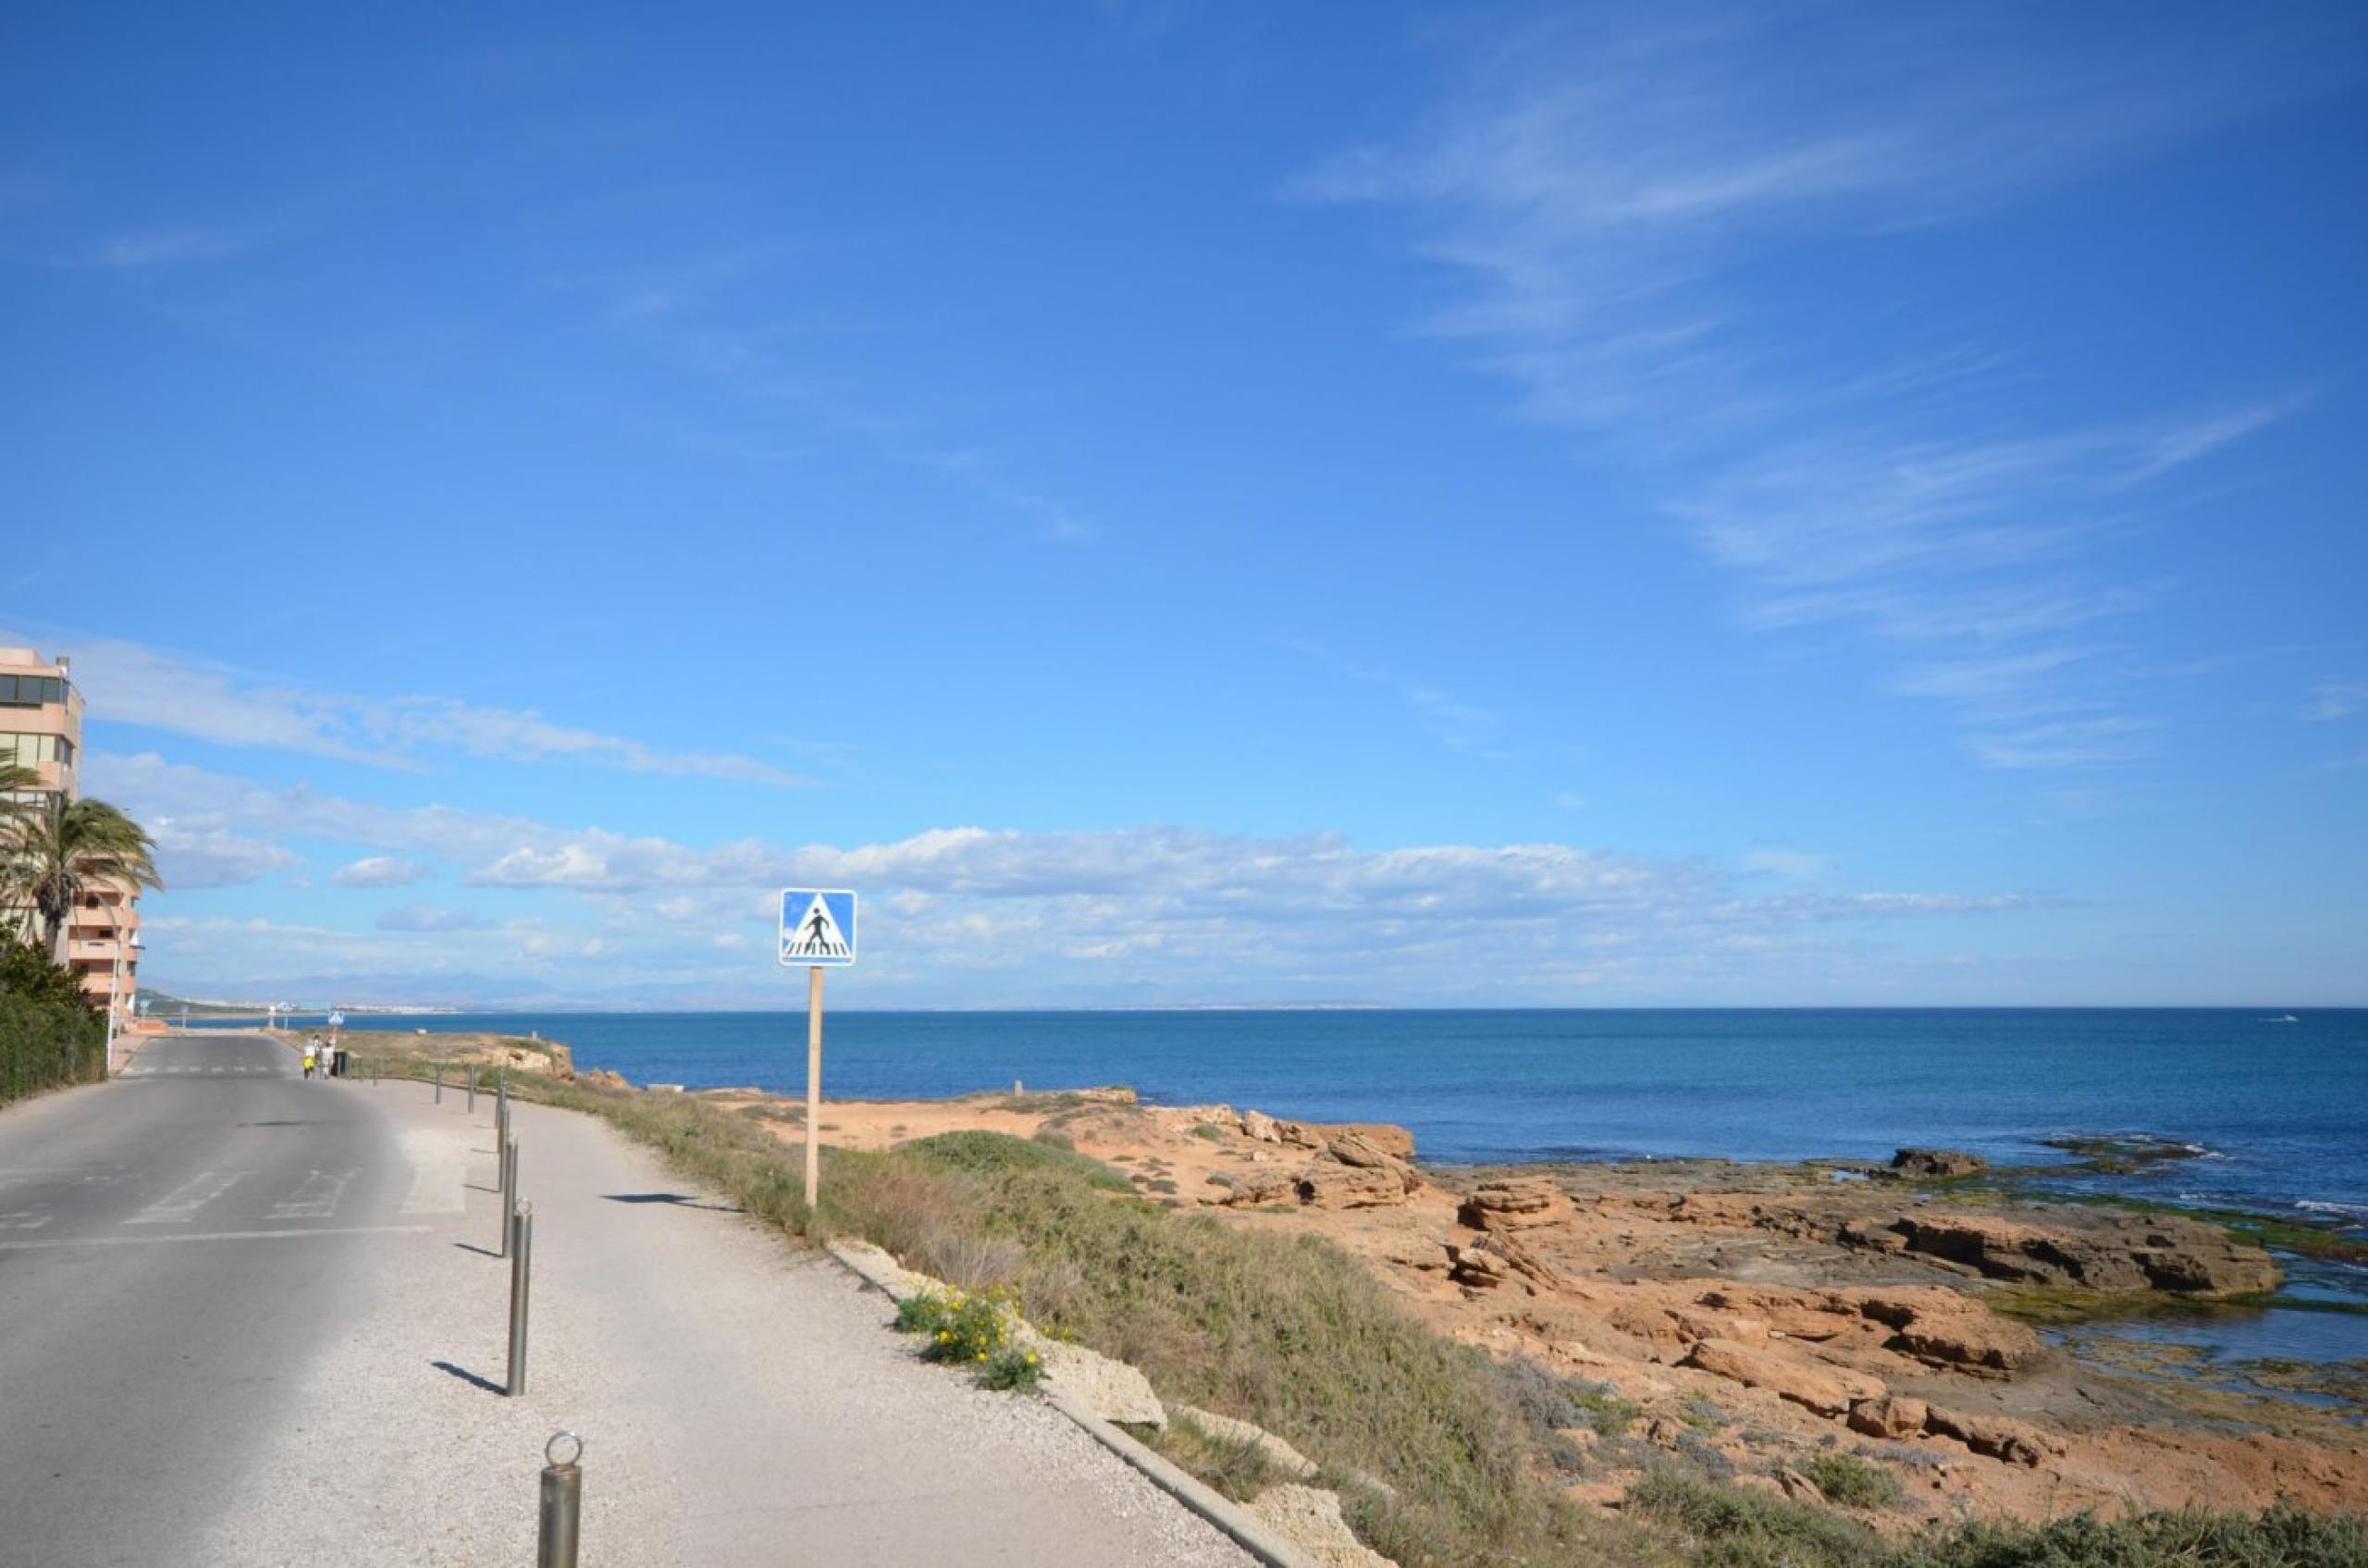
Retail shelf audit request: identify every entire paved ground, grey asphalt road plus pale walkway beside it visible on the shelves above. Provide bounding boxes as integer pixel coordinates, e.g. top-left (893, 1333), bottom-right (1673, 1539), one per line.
top-left (0, 1032), bottom-right (1248, 1568)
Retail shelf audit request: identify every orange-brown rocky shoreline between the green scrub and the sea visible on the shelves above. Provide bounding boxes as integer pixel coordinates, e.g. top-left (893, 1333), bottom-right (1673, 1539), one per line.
top-left (672, 1090), bottom-right (2368, 1527)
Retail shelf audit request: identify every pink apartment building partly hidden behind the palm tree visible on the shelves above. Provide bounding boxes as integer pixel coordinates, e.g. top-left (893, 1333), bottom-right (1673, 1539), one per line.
top-left (0, 649), bottom-right (140, 1028)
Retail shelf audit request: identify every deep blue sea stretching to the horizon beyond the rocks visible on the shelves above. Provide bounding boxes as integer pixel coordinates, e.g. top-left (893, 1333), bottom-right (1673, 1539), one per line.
top-left (230, 1006), bottom-right (2368, 1360)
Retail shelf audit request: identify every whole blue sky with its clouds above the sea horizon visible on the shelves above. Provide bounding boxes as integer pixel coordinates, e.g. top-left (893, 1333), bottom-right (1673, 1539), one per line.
top-left (0, 0), bottom-right (2368, 1006)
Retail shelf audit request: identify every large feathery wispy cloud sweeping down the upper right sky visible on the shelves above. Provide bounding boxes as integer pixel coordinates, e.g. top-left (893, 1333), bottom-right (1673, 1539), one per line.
top-left (1302, 5), bottom-right (2335, 768)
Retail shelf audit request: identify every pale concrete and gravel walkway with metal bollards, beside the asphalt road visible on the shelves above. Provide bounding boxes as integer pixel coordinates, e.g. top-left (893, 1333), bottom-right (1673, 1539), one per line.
top-left (190, 1080), bottom-right (1251, 1568)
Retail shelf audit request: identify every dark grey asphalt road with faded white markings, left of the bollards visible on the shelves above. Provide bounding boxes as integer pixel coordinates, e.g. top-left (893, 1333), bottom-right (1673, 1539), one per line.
top-left (0, 1032), bottom-right (409, 1568)
